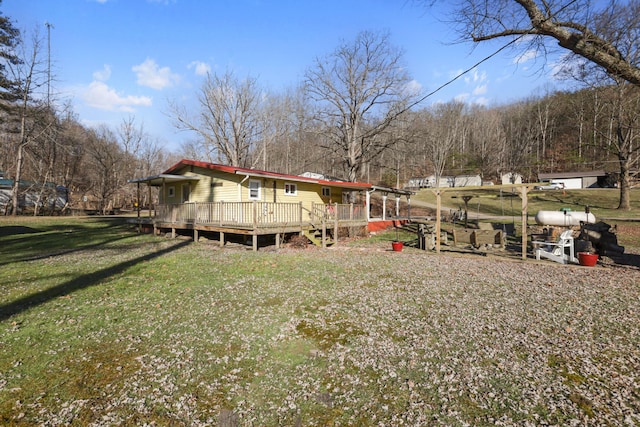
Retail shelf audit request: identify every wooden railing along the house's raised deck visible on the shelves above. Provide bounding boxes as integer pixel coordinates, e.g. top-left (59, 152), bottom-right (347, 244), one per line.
top-left (155, 201), bottom-right (366, 228)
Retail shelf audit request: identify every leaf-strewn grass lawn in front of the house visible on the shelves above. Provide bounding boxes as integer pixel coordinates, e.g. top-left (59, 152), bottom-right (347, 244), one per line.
top-left (0, 218), bottom-right (640, 426)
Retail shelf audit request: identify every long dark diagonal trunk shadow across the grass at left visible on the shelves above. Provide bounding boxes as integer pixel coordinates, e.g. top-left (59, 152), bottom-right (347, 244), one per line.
top-left (0, 241), bottom-right (191, 321)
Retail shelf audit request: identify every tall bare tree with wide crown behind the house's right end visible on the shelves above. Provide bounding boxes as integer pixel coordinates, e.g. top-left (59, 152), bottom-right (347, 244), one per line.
top-left (305, 32), bottom-right (415, 181)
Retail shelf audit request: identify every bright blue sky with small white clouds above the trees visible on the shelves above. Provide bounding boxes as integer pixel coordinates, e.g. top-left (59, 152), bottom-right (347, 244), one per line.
top-left (0, 0), bottom-right (554, 150)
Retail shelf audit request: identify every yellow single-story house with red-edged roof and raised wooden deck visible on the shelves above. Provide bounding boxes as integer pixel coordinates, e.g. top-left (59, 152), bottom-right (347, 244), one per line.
top-left (129, 159), bottom-right (373, 250)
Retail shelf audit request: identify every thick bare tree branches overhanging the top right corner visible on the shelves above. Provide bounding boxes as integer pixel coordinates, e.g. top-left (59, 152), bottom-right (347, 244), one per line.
top-left (453, 0), bottom-right (640, 85)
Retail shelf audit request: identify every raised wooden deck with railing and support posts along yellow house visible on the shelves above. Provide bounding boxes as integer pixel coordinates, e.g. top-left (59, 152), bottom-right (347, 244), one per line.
top-left (132, 201), bottom-right (367, 250)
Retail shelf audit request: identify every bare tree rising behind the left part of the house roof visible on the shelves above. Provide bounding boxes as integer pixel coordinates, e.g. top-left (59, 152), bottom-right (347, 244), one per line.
top-left (170, 72), bottom-right (263, 167)
